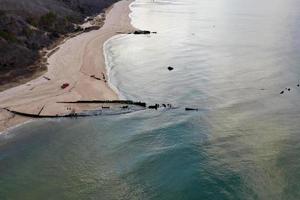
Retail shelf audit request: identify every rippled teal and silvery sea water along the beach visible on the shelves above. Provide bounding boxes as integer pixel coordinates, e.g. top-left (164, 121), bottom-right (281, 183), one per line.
top-left (0, 0), bottom-right (300, 200)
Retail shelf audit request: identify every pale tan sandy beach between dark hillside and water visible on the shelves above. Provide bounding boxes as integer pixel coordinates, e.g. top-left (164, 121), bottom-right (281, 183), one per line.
top-left (0, 0), bottom-right (135, 132)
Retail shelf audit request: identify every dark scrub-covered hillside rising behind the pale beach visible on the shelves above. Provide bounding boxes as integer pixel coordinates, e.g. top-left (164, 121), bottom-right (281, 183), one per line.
top-left (0, 0), bottom-right (117, 91)
